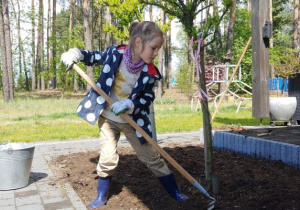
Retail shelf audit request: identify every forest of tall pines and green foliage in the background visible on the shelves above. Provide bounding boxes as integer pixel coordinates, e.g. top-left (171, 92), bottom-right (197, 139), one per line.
top-left (0, 0), bottom-right (299, 101)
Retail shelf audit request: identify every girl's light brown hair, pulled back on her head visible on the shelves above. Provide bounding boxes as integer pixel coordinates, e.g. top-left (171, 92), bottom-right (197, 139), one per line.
top-left (129, 21), bottom-right (163, 49)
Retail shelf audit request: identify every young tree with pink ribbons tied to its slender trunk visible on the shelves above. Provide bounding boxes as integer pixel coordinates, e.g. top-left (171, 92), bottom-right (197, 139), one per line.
top-left (141, 0), bottom-right (232, 188)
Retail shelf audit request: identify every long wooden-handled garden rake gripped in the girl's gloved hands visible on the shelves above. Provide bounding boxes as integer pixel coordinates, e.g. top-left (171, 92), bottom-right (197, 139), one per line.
top-left (72, 64), bottom-right (215, 206)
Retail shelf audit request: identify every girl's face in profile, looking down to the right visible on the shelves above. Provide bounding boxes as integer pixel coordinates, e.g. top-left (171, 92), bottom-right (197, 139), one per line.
top-left (132, 36), bottom-right (163, 64)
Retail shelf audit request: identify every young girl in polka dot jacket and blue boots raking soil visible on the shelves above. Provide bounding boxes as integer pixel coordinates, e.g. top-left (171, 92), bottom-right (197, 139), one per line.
top-left (61, 21), bottom-right (188, 208)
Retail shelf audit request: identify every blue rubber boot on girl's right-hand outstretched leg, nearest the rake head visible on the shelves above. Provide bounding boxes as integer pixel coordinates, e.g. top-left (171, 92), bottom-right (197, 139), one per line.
top-left (158, 174), bottom-right (189, 203)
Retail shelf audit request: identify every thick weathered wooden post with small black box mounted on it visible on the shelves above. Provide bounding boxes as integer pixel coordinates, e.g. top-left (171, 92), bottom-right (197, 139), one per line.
top-left (251, 0), bottom-right (270, 119)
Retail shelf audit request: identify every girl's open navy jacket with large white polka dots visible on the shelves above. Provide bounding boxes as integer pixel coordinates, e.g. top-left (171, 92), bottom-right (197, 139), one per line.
top-left (77, 45), bottom-right (161, 144)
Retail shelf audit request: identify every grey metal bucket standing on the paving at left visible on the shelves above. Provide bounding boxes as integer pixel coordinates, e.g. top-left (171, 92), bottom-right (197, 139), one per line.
top-left (0, 142), bottom-right (34, 190)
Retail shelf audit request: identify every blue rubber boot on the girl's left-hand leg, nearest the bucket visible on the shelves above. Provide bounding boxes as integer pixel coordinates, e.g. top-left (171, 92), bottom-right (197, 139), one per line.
top-left (89, 177), bottom-right (111, 209)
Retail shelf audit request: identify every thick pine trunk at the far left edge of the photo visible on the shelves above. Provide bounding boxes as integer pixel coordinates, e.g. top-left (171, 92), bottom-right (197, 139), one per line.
top-left (0, 0), bottom-right (14, 101)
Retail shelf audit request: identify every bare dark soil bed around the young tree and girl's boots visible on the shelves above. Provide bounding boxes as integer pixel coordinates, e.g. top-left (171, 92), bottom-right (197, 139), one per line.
top-left (52, 137), bottom-right (300, 210)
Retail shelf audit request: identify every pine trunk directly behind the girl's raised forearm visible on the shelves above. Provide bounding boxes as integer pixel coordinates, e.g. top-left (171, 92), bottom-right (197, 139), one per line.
top-left (82, 0), bottom-right (94, 89)
